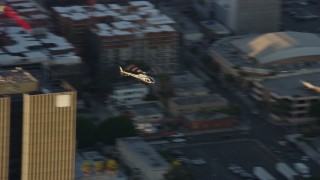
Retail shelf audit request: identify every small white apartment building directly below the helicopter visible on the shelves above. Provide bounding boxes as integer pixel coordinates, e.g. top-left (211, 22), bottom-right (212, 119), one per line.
top-left (110, 83), bottom-right (149, 106)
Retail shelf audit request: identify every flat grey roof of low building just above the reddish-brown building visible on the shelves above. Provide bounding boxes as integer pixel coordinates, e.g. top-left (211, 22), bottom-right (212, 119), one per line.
top-left (171, 94), bottom-right (227, 105)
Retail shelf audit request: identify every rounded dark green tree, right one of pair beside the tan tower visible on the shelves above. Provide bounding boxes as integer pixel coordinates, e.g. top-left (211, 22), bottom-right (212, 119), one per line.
top-left (98, 116), bottom-right (136, 144)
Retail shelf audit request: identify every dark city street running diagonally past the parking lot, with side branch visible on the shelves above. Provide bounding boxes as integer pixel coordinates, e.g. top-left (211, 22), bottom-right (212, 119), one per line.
top-left (175, 43), bottom-right (320, 175)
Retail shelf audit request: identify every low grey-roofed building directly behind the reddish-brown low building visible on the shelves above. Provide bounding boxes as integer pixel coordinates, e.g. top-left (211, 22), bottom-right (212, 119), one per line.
top-left (167, 94), bottom-right (229, 117)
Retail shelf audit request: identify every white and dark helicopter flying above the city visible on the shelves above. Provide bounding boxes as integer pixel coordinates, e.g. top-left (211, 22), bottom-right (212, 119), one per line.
top-left (119, 65), bottom-right (155, 85)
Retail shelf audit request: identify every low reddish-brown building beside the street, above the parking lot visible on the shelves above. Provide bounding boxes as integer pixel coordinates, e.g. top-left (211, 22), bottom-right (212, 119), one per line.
top-left (182, 113), bottom-right (238, 130)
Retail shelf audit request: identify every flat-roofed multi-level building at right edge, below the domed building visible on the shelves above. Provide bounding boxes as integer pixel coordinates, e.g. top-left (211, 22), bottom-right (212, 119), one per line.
top-left (252, 70), bottom-right (320, 123)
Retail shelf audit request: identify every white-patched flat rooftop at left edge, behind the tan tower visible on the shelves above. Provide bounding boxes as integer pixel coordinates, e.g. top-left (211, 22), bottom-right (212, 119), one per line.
top-left (0, 27), bottom-right (81, 66)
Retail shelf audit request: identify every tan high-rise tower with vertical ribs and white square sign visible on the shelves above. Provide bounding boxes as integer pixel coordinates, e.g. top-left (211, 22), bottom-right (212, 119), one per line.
top-left (0, 68), bottom-right (77, 180)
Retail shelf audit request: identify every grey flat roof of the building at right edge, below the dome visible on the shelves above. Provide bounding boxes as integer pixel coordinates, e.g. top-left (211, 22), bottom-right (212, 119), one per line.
top-left (259, 71), bottom-right (320, 97)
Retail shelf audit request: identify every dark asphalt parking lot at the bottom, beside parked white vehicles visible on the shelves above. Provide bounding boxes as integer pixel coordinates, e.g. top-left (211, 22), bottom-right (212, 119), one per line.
top-left (168, 140), bottom-right (282, 180)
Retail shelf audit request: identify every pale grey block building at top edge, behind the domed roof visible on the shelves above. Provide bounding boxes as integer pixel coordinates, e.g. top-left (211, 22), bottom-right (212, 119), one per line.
top-left (214, 0), bottom-right (281, 34)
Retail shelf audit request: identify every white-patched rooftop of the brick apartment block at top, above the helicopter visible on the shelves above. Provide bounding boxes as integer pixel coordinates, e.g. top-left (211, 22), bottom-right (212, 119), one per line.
top-left (52, 1), bottom-right (176, 37)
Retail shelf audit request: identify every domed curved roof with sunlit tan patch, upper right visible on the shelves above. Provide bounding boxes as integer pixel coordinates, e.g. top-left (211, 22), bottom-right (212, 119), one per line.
top-left (231, 31), bottom-right (320, 64)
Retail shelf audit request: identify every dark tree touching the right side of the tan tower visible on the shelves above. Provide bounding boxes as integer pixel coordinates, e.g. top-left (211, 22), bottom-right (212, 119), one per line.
top-left (77, 117), bottom-right (97, 149)
